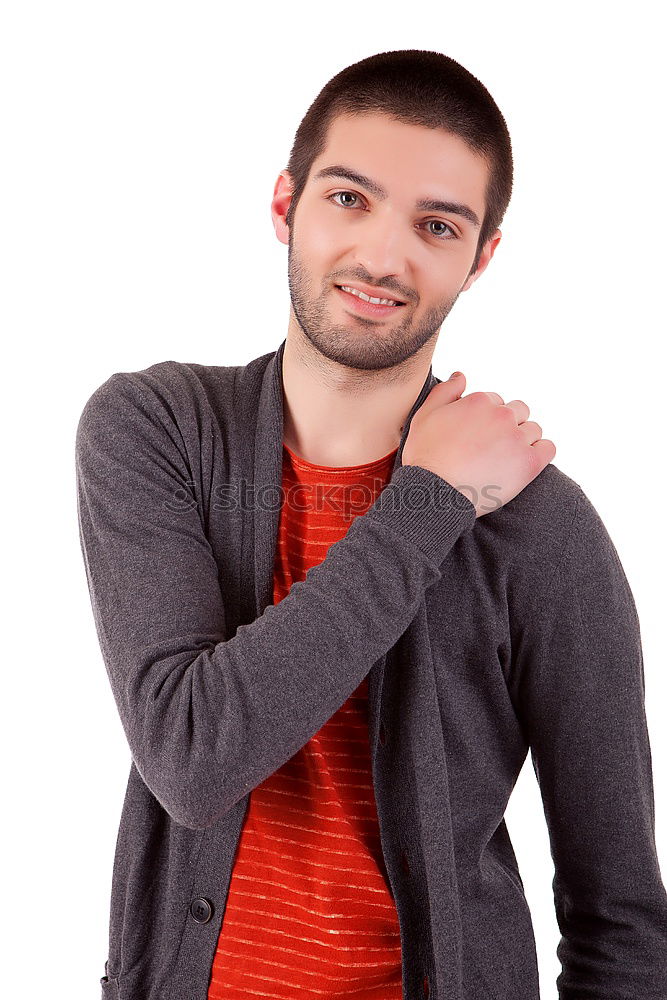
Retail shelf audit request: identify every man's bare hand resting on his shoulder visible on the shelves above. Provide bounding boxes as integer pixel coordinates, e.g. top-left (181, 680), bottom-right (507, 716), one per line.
top-left (402, 372), bottom-right (556, 517)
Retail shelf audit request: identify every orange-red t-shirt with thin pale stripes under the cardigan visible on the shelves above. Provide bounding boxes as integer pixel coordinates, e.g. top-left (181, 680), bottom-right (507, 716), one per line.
top-left (207, 445), bottom-right (402, 1000)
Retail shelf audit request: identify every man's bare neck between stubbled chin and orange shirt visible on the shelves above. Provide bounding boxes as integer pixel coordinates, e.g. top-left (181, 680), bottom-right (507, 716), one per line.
top-left (282, 334), bottom-right (431, 468)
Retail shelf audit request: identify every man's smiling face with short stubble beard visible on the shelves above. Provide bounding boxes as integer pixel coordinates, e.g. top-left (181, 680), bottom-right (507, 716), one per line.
top-left (273, 114), bottom-right (500, 371)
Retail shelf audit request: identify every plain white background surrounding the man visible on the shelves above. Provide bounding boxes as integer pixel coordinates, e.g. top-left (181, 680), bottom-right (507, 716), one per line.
top-left (0, 0), bottom-right (667, 1000)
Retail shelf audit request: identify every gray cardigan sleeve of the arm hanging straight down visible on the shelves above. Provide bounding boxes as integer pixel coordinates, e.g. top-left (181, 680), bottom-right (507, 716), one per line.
top-left (513, 488), bottom-right (667, 1000)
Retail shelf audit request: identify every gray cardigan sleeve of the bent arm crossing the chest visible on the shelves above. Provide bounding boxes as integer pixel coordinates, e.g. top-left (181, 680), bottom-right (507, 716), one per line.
top-left (75, 372), bottom-right (476, 829)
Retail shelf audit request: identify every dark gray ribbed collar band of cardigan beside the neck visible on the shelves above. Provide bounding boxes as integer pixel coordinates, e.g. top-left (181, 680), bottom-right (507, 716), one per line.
top-left (254, 338), bottom-right (441, 616)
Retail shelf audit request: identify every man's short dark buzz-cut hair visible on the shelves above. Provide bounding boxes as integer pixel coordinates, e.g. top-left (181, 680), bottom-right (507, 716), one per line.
top-left (285, 49), bottom-right (513, 274)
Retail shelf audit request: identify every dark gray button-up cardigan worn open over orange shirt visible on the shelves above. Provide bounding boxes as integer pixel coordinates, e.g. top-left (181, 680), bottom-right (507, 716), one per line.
top-left (76, 341), bottom-right (667, 1000)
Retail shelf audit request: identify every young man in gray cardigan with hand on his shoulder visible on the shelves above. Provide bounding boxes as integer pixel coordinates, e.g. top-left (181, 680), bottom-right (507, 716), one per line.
top-left (76, 51), bottom-right (667, 1000)
